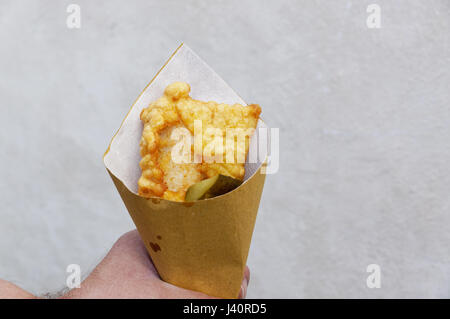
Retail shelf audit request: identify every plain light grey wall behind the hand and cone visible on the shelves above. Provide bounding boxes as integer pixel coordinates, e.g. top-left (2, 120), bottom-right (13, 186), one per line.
top-left (0, 0), bottom-right (450, 298)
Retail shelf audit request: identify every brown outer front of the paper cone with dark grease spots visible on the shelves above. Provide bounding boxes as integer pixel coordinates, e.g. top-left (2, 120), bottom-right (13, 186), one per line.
top-left (107, 171), bottom-right (265, 298)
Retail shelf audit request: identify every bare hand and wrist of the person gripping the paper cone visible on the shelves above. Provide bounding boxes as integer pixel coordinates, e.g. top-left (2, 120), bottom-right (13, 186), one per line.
top-left (0, 230), bottom-right (250, 299)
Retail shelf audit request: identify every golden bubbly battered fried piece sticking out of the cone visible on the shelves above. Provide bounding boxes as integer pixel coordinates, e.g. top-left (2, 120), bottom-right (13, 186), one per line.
top-left (138, 82), bottom-right (261, 201)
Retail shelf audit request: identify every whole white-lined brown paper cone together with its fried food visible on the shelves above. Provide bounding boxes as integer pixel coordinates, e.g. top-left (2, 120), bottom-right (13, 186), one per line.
top-left (104, 44), bottom-right (268, 298)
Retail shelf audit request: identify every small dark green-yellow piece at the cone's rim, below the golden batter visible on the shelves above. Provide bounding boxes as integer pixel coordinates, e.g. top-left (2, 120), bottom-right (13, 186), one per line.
top-left (185, 174), bottom-right (242, 202)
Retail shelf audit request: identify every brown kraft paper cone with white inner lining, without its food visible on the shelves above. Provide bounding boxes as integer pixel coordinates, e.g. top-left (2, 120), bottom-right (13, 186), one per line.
top-left (104, 44), bottom-right (266, 298)
